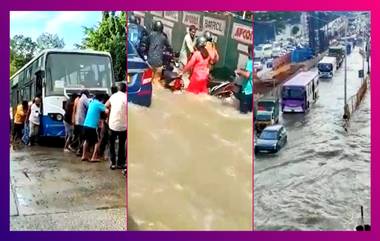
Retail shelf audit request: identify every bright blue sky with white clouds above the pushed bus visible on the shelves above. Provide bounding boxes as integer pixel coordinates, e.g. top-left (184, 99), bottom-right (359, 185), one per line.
top-left (10, 11), bottom-right (102, 49)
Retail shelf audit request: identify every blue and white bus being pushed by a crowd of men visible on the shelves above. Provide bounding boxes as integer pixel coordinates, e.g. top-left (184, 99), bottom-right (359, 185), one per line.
top-left (11, 49), bottom-right (114, 137)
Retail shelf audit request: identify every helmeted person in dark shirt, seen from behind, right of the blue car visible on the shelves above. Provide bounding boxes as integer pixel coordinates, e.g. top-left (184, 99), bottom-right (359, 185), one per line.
top-left (147, 21), bottom-right (170, 86)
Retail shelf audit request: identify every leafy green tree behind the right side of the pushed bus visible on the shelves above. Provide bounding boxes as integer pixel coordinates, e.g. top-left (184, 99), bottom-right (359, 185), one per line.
top-left (76, 12), bottom-right (127, 81)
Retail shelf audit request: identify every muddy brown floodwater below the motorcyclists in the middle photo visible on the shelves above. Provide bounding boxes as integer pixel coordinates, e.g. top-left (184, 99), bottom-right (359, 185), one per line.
top-left (128, 90), bottom-right (252, 230)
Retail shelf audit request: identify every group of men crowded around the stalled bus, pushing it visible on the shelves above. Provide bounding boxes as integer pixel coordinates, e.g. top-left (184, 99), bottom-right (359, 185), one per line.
top-left (12, 83), bottom-right (127, 174)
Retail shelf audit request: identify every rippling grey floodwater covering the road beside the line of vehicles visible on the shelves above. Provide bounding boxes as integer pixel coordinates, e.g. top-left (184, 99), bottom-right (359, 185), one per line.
top-left (254, 49), bottom-right (370, 230)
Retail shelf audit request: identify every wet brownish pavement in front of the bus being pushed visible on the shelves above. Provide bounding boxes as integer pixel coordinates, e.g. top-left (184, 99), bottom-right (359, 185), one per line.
top-left (10, 146), bottom-right (127, 230)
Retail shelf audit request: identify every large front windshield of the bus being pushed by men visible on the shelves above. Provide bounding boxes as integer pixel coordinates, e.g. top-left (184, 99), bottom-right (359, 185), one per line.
top-left (46, 53), bottom-right (112, 96)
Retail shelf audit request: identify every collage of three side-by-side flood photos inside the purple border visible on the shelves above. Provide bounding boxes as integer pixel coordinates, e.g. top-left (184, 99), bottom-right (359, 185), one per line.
top-left (9, 11), bottom-right (371, 231)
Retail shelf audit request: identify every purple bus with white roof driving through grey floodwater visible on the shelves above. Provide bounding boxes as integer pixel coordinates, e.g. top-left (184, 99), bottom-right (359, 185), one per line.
top-left (281, 71), bottom-right (319, 112)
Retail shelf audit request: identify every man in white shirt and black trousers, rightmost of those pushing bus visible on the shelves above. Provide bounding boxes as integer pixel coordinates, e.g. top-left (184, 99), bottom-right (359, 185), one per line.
top-left (106, 83), bottom-right (127, 170)
